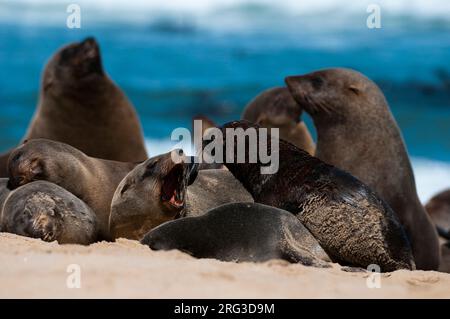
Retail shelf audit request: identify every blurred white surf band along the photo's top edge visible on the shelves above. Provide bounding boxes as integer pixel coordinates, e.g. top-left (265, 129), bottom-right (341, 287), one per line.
top-left (0, 0), bottom-right (450, 29)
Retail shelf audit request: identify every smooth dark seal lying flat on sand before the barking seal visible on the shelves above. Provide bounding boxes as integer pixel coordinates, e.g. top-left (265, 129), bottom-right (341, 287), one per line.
top-left (141, 203), bottom-right (330, 267)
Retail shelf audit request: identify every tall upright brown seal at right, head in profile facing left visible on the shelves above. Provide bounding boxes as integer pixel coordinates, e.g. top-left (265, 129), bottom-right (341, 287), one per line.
top-left (286, 69), bottom-right (440, 270)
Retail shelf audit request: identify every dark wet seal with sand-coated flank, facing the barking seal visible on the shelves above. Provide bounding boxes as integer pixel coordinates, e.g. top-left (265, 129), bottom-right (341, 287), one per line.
top-left (205, 121), bottom-right (415, 272)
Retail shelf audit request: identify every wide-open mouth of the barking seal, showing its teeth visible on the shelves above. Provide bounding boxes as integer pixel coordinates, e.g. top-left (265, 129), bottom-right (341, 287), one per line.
top-left (161, 164), bottom-right (186, 209)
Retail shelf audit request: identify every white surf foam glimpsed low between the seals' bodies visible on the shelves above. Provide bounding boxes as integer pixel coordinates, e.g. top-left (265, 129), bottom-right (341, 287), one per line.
top-left (146, 139), bottom-right (450, 204)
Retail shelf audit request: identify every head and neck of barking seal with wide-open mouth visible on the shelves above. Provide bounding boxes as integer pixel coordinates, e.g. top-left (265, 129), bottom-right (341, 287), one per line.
top-left (109, 149), bottom-right (198, 239)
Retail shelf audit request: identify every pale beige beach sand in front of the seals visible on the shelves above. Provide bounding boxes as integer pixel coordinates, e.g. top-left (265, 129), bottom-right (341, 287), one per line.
top-left (0, 233), bottom-right (450, 298)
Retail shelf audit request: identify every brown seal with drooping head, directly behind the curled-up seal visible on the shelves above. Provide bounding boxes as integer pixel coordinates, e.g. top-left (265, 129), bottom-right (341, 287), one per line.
top-left (8, 139), bottom-right (136, 239)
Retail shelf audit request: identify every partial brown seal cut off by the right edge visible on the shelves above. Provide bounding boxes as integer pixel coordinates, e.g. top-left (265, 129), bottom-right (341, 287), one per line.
top-left (425, 189), bottom-right (450, 240)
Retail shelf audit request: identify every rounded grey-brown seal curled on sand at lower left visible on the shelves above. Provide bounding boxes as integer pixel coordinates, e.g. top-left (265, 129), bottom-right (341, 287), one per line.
top-left (0, 181), bottom-right (97, 245)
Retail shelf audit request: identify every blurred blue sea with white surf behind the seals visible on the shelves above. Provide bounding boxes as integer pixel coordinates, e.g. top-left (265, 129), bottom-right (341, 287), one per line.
top-left (0, 0), bottom-right (450, 201)
